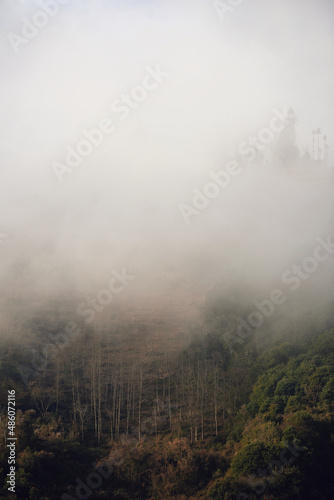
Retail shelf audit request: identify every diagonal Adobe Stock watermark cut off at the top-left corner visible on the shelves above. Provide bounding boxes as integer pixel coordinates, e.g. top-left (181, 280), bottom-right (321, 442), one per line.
top-left (7, 0), bottom-right (71, 54)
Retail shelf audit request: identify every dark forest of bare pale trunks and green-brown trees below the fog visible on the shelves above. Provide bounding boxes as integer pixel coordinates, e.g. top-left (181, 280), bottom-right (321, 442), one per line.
top-left (0, 287), bottom-right (334, 500)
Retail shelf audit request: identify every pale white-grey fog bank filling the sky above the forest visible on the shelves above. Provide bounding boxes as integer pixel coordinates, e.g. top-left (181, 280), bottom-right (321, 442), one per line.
top-left (0, 0), bottom-right (334, 320)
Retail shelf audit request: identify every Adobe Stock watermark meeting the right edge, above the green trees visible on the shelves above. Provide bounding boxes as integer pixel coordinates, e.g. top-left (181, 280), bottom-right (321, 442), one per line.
top-left (223, 235), bottom-right (334, 349)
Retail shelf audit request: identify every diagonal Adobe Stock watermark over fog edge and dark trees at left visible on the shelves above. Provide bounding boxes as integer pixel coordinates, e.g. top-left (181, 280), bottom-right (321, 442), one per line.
top-left (17, 268), bottom-right (135, 386)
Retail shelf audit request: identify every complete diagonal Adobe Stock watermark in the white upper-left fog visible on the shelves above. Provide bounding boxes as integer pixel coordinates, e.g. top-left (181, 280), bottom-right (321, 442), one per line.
top-left (52, 65), bottom-right (169, 182)
